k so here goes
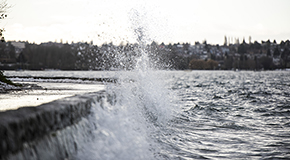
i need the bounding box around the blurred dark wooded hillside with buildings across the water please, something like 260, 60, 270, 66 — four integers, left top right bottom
0, 37, 290, 70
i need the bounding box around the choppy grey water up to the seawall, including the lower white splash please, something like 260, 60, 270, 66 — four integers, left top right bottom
71, 71, 290, 159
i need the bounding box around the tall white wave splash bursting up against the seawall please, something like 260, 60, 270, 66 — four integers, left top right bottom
77, 6, 175, 159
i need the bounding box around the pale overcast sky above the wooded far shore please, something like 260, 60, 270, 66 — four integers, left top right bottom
0, 0, 290, 44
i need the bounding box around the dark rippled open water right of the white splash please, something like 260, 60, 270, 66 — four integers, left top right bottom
158, 71, 290, 159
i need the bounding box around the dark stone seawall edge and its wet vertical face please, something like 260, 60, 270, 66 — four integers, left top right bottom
0, 91, 105, 160
